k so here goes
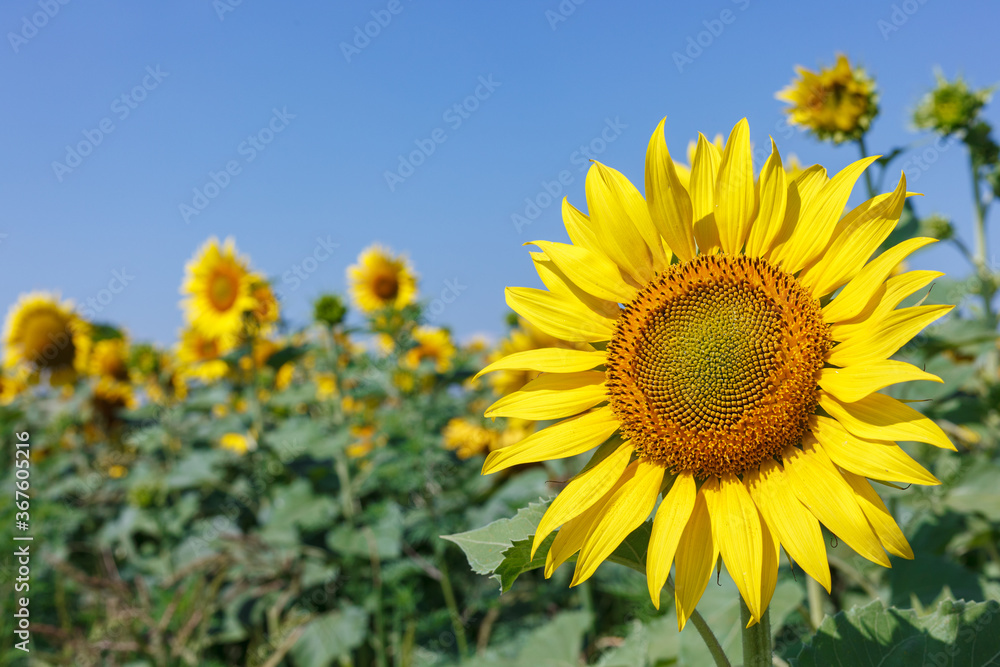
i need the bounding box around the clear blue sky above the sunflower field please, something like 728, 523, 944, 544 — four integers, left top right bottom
0, 0, 1000, 343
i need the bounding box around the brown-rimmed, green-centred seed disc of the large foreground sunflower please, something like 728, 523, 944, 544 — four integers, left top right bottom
607, 255, 831, 477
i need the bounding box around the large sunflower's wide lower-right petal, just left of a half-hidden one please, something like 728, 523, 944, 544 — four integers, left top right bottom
783, 436, 889, 567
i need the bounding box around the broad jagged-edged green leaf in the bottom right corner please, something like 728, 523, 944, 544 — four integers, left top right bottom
793, 600, 1000, 667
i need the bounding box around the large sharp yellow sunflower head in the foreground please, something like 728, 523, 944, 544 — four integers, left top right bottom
483, 119, 954, 628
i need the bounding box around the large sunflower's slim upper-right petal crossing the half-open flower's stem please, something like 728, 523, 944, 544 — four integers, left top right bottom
784, 156, 878, 273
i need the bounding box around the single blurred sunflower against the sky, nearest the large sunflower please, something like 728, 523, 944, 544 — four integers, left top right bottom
347, 244, 417, 313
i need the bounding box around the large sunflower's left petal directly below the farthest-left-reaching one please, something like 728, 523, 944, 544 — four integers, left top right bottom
486, 371, 607, 420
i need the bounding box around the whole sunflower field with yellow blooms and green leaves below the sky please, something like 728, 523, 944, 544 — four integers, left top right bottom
0, 56, 1000, 667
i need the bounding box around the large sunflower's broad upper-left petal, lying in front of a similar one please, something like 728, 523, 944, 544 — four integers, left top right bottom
584, 162, 666, 283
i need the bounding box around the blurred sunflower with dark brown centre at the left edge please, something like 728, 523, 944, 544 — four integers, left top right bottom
3, 292, 91, 385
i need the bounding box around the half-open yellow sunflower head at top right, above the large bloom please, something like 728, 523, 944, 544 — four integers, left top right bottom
775, 54, 878, 144
